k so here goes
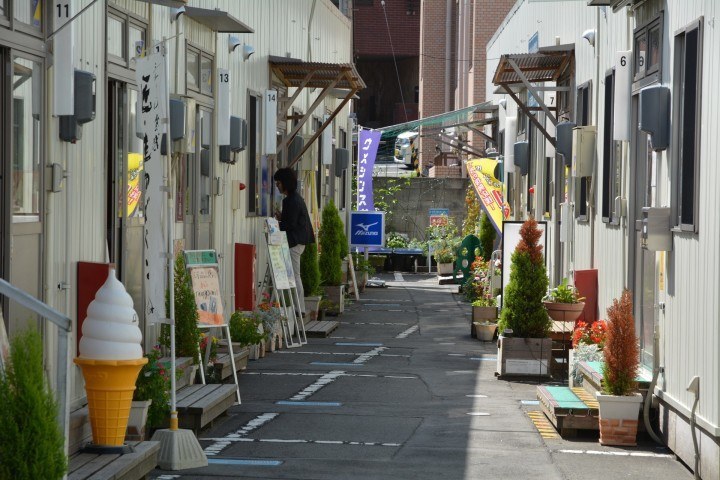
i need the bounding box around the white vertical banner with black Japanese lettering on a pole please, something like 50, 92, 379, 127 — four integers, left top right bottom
135, 49, 169, 322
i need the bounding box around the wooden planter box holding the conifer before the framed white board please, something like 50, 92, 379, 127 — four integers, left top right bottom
496, 336, 552, 377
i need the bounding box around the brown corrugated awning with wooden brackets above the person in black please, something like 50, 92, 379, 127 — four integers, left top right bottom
268, 56, 366, 166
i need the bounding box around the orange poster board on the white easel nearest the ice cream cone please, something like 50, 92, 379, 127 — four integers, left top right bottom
184, 250, 225, 326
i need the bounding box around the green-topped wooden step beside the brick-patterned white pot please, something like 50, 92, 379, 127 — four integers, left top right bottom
537, 385, 600, 438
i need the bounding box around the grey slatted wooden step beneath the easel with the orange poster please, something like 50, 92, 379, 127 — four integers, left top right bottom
177, 383, 236, 434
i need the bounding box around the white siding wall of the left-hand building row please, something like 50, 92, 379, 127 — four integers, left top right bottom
46, 0, 352, 400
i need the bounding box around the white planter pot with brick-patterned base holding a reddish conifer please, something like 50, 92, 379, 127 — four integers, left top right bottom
596, 392, 643, 447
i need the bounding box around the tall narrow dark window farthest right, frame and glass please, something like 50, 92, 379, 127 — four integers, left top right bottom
672, 18, 703, 232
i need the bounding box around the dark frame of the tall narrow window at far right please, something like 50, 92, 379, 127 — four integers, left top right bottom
671, 17, 704, 233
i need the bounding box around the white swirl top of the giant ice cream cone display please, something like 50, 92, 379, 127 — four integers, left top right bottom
79, 269, 143, 360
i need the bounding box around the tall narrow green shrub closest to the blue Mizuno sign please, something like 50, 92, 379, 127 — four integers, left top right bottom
318, 200, 348, 313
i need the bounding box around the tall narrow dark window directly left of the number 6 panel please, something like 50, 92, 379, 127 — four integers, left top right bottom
600, 70, 620, 224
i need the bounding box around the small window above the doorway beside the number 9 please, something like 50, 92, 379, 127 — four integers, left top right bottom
633, 12, 663, 88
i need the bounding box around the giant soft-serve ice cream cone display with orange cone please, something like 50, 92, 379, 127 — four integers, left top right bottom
74, 266, 147, 447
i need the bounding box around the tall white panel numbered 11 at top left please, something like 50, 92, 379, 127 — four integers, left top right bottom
53, 0, 75, 115
